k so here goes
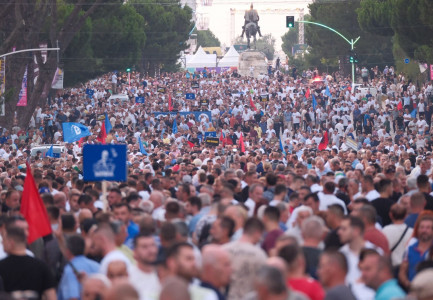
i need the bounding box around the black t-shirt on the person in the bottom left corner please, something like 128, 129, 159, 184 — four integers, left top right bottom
0, 255, 56, 298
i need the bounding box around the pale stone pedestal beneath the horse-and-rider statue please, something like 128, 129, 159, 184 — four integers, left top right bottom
239, 50, 268, 78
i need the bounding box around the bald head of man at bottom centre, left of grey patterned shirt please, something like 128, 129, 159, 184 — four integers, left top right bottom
201, 245, 232, 300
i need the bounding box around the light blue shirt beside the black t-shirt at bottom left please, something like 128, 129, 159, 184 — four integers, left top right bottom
57, 255, 99, 300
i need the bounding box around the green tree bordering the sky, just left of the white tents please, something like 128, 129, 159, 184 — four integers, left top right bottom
129, 0, 193, 74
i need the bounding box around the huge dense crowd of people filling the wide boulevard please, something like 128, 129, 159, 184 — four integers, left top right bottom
0, 62, 433, 300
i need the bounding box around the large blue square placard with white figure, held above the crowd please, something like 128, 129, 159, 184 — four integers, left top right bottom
83, 145, 127, 181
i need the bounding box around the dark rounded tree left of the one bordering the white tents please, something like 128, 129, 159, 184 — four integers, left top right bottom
61, 4, 146, 86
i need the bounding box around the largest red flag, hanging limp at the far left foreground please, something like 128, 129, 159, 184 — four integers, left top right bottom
20, 163, 52, 244
